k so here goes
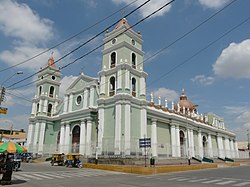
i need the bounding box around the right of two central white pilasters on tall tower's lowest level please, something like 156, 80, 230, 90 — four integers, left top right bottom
124, 104, 131, 155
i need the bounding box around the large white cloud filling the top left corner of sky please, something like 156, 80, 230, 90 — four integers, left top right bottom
0, 0, 53, 43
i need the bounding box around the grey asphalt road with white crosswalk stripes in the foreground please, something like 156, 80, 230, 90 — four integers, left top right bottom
6, 163, 250, 187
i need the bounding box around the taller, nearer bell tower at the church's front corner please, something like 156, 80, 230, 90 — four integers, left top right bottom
98, 18, 147, 155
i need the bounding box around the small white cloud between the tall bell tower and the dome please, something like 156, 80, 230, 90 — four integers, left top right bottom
152, 88, 178, 101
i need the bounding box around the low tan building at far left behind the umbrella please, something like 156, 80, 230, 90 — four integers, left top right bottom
0, 129, 26, 145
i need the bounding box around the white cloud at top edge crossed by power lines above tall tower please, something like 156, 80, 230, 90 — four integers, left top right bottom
112, 0, 171, 17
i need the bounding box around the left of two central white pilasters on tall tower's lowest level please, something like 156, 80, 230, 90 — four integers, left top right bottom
115, 104, 122, 155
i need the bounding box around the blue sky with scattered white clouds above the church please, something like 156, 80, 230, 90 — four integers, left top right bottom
0, 0, 250, 141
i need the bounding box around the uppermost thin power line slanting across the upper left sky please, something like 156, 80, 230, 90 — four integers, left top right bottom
0, 0, 138, 73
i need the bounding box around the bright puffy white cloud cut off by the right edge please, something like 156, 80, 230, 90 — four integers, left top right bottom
213, 39, 250, 78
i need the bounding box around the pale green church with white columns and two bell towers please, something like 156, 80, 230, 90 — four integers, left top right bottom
27, 19, 238, 158
